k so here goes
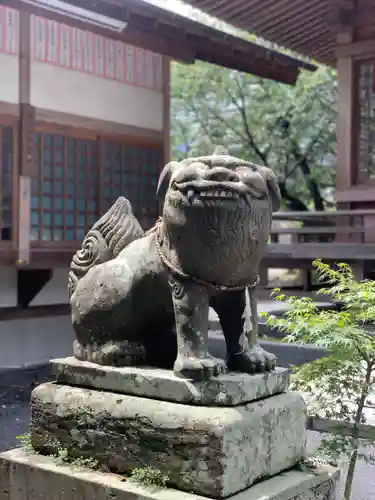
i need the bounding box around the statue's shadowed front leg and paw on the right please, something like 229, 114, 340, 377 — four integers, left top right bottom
212, 291, 276, 373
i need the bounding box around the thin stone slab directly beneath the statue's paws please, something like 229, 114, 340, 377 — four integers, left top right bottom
51, 357, 289, 406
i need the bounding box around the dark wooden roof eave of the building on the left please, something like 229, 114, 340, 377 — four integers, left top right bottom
0, 0, 316, 84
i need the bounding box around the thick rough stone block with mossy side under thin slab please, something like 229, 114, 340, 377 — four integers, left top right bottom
31, 384, 306, 498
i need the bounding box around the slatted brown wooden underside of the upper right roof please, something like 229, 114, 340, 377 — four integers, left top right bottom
185, 0, 375, 66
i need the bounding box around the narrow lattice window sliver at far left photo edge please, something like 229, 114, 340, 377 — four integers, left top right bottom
0, 125, 13, 241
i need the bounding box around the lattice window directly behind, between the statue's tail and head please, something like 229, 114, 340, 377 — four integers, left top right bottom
101, 141, 162, 228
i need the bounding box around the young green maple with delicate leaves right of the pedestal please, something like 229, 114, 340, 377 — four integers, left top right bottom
263, 260, 375, 500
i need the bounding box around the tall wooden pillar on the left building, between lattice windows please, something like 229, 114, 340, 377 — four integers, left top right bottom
17, 10, 35, 265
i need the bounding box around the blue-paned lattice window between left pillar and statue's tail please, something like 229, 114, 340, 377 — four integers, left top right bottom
31, 133, 99, 242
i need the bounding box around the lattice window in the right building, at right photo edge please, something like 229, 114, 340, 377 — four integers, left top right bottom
358, 62, 375, 181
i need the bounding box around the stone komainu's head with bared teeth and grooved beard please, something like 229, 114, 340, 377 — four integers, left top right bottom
157, 148, 281, 286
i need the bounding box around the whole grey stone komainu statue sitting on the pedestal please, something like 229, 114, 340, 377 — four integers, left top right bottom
69, 149, 280, 380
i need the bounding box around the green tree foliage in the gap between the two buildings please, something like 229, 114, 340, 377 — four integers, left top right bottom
171, 62, 336, 209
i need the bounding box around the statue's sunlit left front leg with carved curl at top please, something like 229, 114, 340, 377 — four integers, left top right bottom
170, 278, 226, 380
